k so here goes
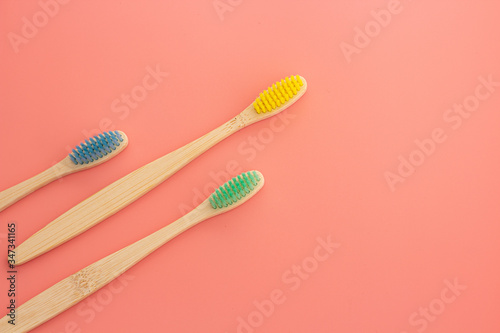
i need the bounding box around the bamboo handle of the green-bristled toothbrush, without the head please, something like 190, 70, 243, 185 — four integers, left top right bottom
0, 208, 207, 333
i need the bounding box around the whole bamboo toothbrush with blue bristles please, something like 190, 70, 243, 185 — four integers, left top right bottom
0, 131, 128, 212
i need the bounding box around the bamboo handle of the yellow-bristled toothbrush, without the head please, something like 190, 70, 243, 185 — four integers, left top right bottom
16, 115, 247, 265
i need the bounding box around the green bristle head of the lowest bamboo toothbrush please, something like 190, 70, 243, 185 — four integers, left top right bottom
209, 171, 260, 209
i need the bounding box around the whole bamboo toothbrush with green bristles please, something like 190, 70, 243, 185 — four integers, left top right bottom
0, 171, 264, 333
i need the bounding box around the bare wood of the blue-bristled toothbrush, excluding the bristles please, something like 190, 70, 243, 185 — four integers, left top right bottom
0, 131, 128, 212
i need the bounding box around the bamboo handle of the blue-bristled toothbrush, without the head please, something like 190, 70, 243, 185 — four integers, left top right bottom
0, 158, 74, 212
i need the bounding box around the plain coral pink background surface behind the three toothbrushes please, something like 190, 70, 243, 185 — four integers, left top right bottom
0, 0, 500, 333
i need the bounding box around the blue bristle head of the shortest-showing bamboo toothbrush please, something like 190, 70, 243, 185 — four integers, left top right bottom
69, 131, 123, 164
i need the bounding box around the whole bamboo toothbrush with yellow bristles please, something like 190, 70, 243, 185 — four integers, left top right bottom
16, 75, 307, 265
